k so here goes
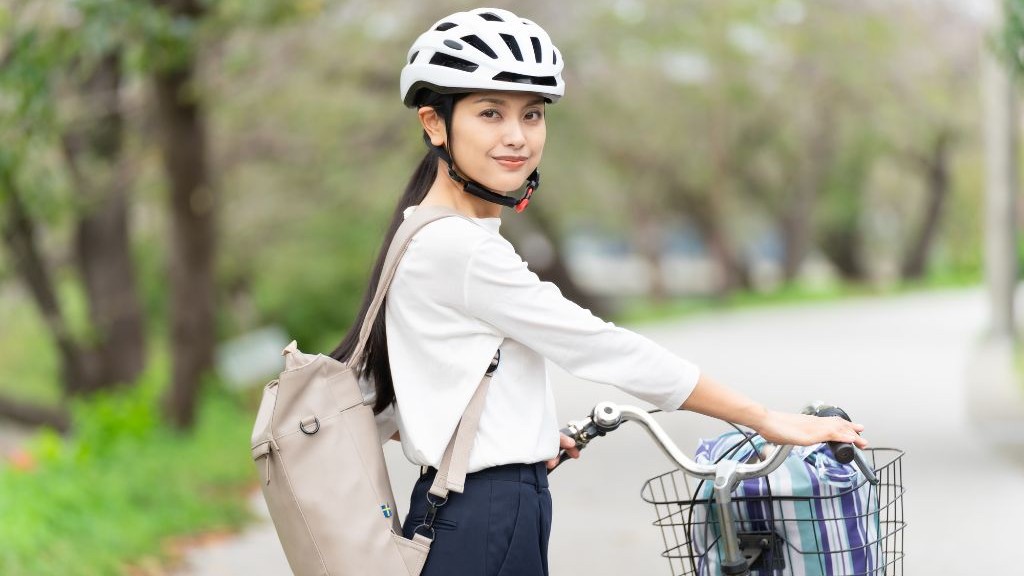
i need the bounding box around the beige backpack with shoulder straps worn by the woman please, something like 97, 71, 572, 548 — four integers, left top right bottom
246, 206, 487, 576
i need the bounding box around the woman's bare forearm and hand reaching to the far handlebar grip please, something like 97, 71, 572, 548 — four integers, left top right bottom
679, 374, 867, 448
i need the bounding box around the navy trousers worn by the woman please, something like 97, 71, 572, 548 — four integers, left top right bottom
402, 462, 551, 576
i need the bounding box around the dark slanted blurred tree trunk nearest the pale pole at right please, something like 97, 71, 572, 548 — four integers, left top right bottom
902, 130, 951, 280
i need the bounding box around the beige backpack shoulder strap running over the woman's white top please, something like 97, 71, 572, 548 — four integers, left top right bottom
348, 206, 501, 498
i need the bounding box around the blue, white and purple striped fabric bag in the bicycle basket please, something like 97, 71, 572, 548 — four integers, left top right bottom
690, 433, 883, 576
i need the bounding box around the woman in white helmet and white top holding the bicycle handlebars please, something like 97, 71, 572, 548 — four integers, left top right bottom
332, 8, 866, 576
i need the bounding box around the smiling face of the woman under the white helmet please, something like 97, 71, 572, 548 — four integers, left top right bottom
451, 92, 547, 193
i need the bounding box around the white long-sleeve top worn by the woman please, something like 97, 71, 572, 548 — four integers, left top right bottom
382, 208, 699, 471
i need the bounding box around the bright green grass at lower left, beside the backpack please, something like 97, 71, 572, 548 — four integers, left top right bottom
0, 372, 253, 576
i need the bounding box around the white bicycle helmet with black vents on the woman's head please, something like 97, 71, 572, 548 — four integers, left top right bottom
400, 8, 565, 108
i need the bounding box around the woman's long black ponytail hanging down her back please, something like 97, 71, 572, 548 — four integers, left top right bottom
331, 89, 462, 414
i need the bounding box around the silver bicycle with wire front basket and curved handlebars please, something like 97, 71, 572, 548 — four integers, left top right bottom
559, 402, 906, 576
